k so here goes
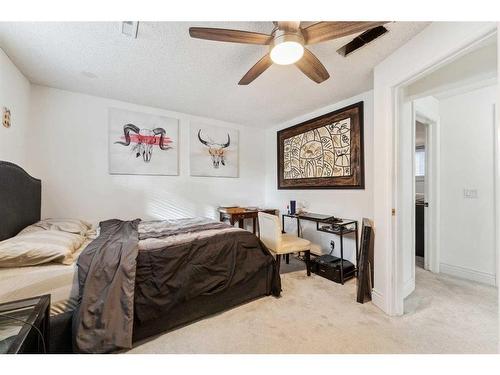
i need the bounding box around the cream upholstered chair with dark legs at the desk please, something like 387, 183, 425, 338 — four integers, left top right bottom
259, 212, 311, 276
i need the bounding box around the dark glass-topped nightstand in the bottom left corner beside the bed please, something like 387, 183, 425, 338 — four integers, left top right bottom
0, 295, 50, 354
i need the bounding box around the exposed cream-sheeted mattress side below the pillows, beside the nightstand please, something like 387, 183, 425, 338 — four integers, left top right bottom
0, 239, 91, 315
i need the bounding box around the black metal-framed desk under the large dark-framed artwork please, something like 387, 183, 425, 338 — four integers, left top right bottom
281, 213, 359, 284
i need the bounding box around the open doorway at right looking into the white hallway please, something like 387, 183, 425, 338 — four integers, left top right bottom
396, 35, 498, 303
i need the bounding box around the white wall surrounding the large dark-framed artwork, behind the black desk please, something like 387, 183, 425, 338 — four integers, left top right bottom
266, 91, 373, 262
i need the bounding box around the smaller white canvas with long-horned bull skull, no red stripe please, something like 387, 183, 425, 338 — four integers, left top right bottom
190, 123, 239, 177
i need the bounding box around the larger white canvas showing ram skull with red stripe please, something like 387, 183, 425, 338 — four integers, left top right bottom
109, 108, 179, 175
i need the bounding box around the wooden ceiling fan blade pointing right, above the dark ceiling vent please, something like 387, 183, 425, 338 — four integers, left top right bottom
302, 21, 387, 44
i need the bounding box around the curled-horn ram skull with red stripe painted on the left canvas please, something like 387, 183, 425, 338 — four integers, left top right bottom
115, 124, 172, 163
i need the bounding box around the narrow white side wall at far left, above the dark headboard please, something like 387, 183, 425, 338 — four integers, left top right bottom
0, 49, 30, 171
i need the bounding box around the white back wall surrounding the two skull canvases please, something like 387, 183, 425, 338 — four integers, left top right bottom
29, 86, 265, 226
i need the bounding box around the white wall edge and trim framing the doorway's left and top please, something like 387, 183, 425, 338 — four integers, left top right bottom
373, 22, 497, 315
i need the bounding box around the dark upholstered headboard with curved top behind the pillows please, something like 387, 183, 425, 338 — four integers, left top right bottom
0, 161, 42, 241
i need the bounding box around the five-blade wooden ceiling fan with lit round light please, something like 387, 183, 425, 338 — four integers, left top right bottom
189, 21, 387, 85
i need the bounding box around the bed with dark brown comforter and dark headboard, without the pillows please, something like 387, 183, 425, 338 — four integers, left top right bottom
0, 161, 281, 353
